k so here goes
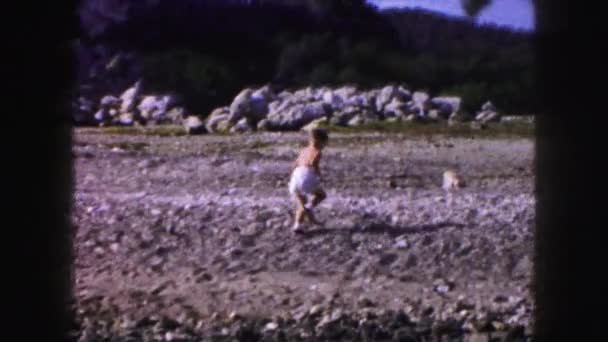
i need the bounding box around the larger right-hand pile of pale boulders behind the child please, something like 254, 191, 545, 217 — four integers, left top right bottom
205, 85, 500, 133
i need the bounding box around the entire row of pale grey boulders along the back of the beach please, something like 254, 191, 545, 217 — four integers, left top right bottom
74, 81, 501, 134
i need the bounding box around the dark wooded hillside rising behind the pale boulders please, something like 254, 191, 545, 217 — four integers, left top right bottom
92, 0, 538, 116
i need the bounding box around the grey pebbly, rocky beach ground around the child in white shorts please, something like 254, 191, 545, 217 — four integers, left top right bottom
73, 129, 535, 341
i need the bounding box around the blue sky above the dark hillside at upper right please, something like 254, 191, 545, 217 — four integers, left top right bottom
368, 0, 534, 31
